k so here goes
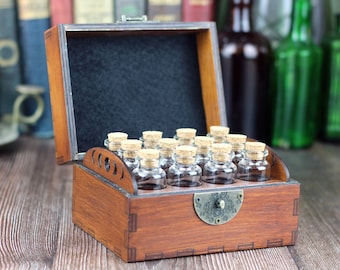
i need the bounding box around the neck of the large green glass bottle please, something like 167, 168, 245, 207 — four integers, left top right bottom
290, 0, 312, 42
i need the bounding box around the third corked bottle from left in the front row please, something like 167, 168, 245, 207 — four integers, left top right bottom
202, 143, 237, 185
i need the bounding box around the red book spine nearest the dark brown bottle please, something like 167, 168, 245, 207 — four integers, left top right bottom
182, 0, 215, 22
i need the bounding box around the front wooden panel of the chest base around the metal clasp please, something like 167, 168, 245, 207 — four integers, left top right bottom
129, 184, 300, 261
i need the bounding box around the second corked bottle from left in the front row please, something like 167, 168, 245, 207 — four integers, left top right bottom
168, 145, 202, 187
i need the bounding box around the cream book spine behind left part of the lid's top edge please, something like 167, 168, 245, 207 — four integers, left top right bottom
73, 0, 114, 24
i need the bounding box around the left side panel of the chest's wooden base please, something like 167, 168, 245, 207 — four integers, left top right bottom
72, 165, 129, 260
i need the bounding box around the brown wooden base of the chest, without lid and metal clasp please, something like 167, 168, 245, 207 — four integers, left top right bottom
73, 148, 300, 262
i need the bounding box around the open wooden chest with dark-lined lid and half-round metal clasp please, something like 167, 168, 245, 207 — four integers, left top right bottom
45, 22, 300, 262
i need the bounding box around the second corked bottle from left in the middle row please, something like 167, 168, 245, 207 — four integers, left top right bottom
159, 138, 178, 174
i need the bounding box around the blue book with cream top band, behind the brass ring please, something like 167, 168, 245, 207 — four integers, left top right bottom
17, 0, 53, 138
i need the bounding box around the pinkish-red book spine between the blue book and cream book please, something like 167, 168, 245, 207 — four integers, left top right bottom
50, 0, 73, 26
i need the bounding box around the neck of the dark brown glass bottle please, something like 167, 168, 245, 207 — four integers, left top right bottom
229, 0, 253, 32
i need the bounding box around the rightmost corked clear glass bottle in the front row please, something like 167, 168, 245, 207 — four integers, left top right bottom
237, 142, 270, 182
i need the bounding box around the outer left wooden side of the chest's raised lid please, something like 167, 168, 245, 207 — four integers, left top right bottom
45, 26, 72, 164
